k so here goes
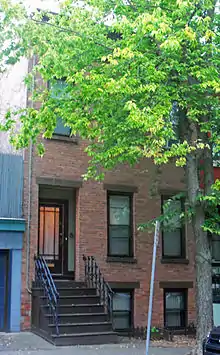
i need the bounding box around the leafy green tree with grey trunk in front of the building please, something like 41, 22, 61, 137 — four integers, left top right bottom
0, 0, 220, 354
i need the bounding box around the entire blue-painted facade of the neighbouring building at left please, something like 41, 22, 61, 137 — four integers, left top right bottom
0, 154, 25, 332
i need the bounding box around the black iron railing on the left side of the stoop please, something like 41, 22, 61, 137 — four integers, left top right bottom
35, 256, 59, 335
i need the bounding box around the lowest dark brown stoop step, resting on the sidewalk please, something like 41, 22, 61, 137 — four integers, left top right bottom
52, 331, 118, 346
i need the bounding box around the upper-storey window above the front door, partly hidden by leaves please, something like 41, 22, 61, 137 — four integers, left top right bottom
49, 79, 71, 137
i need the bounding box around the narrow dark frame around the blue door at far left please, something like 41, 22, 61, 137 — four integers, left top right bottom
0, 249, 10, 331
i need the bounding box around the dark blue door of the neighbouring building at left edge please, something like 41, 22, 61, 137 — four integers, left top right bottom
0, 251, 7, 331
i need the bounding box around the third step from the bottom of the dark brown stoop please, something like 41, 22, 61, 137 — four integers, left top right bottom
45, 313, 108, 324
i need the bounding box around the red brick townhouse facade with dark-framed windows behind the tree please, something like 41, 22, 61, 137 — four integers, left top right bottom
22, 78, 195, 340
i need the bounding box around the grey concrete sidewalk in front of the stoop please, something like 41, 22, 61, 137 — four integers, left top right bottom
0, 333, 189, 355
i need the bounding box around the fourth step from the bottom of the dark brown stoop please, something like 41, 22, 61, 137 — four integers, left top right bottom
41, 303, 104, 314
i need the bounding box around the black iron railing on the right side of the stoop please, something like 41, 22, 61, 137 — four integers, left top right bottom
83, 255, 114, 322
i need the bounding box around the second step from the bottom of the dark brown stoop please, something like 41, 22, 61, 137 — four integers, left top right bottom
48, 322, 112, 334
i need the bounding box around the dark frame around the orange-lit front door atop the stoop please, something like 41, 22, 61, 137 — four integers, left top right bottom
38, 198, 69, 275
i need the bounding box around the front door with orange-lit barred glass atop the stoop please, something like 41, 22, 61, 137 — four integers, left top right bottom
38, 200, 68, 275
